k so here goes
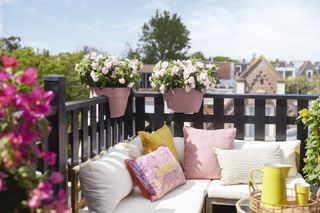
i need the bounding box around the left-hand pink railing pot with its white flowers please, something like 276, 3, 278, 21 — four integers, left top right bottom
75, 52, 142, 118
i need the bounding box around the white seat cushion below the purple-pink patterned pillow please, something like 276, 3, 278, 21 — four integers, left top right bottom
80, 180, 210, 213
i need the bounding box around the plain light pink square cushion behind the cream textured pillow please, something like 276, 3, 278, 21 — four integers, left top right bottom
183, 127, 236, 179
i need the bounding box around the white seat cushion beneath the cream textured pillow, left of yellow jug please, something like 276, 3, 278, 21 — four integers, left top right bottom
208, 174, 305, 199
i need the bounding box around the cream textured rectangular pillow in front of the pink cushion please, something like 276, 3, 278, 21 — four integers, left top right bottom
215, 146, 281, 185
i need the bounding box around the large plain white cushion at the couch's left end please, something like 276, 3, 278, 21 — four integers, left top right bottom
80, 144, 133, 213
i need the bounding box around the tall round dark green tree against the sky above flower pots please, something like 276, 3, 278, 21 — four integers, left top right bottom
139, 10, 190, 64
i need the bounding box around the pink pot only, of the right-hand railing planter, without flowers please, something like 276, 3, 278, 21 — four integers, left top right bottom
163, 88, 203, 113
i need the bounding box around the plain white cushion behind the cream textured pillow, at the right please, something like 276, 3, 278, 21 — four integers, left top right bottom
235, 140, 301, 177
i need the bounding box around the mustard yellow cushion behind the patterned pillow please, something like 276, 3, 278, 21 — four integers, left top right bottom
138, 125, 179, 160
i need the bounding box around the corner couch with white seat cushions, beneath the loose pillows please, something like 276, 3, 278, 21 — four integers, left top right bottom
72, 137, 304, 213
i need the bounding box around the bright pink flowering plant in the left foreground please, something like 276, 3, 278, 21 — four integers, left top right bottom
0, 56, 68, 213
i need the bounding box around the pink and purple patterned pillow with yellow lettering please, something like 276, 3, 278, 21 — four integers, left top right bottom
125, 145, 186, 201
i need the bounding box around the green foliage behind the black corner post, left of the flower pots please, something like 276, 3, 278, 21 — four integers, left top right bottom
5, 47, 89, 101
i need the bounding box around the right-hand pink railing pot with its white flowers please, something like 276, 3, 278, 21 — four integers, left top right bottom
150, 59, 218, 113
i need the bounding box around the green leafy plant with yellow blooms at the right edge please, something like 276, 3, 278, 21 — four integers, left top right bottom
297, 98, 320, 193
